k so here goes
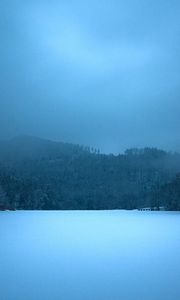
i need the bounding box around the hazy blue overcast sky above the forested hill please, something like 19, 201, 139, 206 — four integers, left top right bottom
0, 0, 180, 153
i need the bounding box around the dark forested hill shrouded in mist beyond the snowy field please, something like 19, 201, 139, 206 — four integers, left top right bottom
0, 137, 180, 210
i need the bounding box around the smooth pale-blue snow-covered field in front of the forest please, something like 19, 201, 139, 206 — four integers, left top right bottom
0, 211, 180, 300
